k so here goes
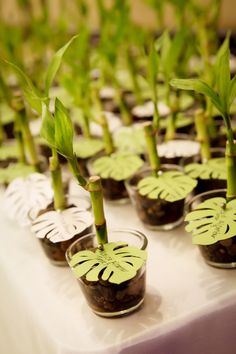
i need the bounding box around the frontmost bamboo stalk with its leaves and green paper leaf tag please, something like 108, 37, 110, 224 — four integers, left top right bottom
41, 99, 146, 310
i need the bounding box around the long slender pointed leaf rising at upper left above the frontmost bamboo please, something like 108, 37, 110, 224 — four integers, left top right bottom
45, 35, 78, 97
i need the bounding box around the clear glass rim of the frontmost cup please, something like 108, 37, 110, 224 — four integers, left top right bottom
65, 228, 148, 263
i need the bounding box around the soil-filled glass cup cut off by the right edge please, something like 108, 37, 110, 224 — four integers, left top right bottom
186, 189, 236, 268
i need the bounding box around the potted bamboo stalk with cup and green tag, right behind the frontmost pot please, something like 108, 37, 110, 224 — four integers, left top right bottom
127, 122, 197, 230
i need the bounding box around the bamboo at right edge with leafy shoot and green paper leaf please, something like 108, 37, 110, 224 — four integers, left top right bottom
171, 37, 236, 265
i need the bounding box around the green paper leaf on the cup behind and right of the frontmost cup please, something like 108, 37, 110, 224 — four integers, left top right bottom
138, 171, 197, 202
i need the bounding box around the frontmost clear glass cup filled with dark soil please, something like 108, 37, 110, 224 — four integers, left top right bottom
66, 229, 148, 317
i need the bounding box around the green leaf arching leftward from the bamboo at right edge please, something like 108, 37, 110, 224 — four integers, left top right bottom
170, 79, 225, 115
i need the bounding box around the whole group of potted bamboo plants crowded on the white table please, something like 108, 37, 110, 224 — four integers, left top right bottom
0, 0, 236, 317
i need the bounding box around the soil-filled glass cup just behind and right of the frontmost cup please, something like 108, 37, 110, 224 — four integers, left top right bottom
125, 164, 185, 230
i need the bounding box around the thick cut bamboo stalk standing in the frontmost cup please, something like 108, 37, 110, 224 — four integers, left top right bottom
88, 176, 108, 247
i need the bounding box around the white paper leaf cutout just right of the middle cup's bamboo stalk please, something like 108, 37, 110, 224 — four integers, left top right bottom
157, 140, 200, 158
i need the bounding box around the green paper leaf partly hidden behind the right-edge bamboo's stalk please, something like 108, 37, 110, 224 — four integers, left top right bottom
184, 157, 227, 180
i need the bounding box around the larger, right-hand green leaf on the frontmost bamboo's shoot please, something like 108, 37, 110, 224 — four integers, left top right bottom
55, 99, 74, 159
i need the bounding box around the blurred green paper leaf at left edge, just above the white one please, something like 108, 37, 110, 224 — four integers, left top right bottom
0, 163, 35, 183
